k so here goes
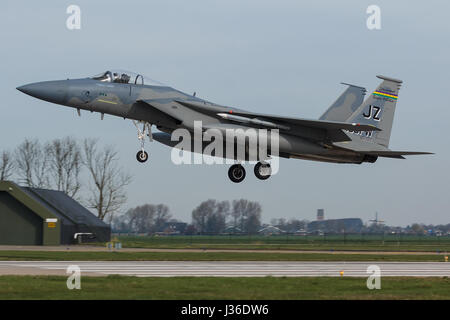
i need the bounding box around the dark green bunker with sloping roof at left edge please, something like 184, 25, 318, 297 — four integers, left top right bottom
0, 181, 111, 245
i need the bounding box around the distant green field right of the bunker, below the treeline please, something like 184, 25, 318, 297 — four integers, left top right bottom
110, 235, 450, 252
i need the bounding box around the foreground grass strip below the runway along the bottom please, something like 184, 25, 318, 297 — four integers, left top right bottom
0, 276, 450, 300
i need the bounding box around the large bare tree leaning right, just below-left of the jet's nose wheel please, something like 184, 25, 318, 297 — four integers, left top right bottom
83, 139, 131, 220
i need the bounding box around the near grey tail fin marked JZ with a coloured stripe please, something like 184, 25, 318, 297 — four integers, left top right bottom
346, 76, 402, 148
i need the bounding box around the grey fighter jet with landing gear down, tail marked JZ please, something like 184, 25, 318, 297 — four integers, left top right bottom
17, 70, 430, 183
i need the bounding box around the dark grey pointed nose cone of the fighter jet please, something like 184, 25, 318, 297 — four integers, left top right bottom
16, 80, 67, 103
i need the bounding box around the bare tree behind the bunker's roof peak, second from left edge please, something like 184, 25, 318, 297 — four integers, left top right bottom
16, 139, 50, 188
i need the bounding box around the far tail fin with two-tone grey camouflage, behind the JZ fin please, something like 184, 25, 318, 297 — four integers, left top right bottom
319, 83, 366, 122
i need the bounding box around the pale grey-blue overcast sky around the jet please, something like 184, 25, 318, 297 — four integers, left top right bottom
0, 0, 450, 226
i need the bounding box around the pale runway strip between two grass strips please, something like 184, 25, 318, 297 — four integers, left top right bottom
0, 261, 450, 277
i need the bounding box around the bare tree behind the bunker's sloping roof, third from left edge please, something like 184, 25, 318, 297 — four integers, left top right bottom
45, 137, 82, 198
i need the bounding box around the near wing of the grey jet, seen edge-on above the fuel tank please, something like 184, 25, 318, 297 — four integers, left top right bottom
176, 101, 380, 141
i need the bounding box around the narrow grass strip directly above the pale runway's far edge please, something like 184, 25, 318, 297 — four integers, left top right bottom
0, 251, 444, 262
